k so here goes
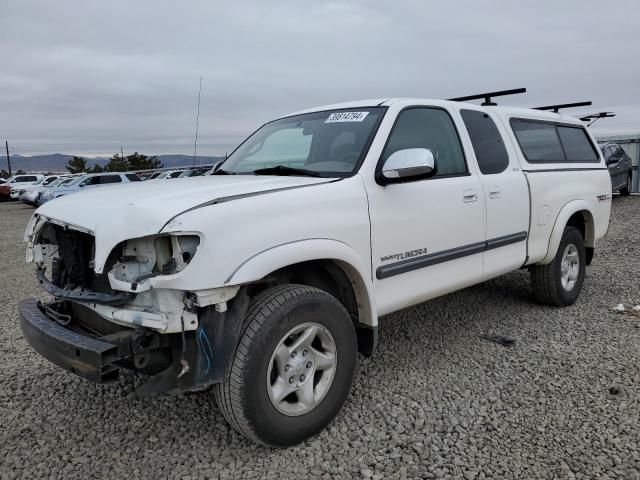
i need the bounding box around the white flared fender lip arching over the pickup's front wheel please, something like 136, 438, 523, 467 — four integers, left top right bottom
225, 238, 378, 327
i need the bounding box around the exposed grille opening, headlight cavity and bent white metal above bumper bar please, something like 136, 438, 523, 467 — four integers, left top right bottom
27, 218, 238, 333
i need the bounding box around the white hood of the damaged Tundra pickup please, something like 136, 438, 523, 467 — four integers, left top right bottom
32, 175, 331, 272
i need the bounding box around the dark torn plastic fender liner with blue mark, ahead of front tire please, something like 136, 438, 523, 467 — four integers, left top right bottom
136, 289, 249, 396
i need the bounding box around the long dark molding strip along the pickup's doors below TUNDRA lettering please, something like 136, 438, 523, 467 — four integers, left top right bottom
376, 232, 528, 280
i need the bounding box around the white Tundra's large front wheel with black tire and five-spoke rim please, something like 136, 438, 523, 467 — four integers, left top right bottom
214, 285, 357, 447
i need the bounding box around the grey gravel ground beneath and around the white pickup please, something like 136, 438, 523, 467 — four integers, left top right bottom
0, 196, 640, 479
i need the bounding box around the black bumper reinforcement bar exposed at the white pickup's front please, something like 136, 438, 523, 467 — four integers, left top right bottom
19, 298, 120, 383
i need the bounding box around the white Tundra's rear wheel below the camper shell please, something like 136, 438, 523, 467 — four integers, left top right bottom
531, 226, 586, 307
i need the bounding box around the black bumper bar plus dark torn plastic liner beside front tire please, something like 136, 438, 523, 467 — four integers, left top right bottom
19, 291, 249, 396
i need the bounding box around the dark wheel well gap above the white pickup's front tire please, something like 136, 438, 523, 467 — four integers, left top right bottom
248, 260, 377, 355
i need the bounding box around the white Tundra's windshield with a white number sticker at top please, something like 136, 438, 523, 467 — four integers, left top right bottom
220, 107, 386, 177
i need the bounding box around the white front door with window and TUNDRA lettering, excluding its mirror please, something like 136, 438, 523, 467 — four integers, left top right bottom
368, 107, 485, 315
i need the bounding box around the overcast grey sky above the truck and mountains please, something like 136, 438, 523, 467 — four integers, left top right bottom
0, 0, 640, 155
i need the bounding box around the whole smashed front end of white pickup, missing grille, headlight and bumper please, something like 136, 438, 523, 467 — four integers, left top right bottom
20, 215, 248, 395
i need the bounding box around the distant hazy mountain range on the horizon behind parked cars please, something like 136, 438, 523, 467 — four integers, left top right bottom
0, 153, 224, 172
